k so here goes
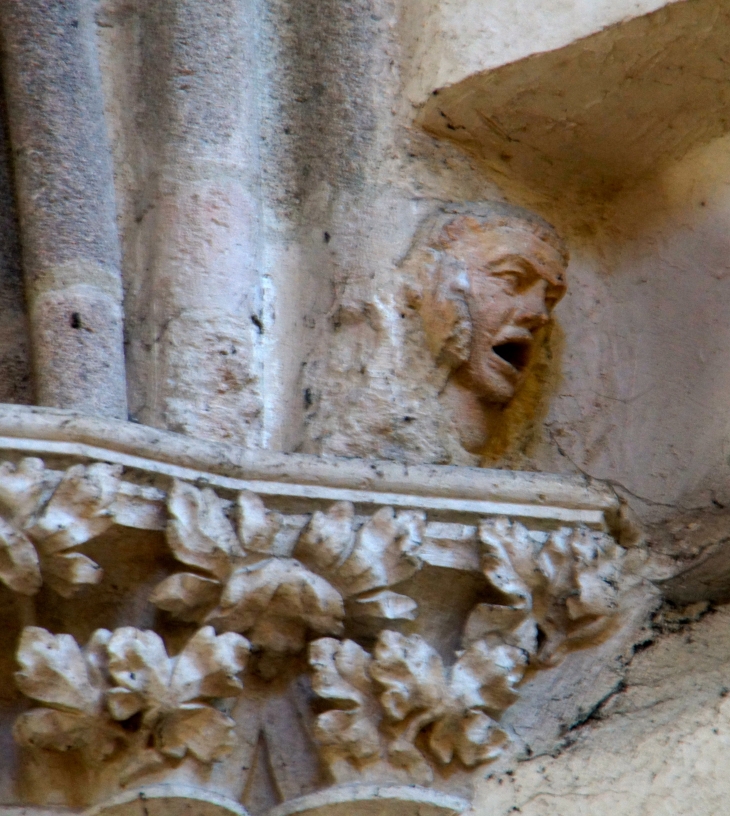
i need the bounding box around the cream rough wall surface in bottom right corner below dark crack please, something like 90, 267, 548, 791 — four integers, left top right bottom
475, 608, 730, 816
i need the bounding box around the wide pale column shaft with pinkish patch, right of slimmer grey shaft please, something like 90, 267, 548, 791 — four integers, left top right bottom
128, 0, 262, 446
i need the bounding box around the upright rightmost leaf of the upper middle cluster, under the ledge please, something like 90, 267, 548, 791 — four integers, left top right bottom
328, 507, 425, 597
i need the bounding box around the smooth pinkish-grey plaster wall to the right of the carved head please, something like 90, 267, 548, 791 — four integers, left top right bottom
533, 130, 730, 516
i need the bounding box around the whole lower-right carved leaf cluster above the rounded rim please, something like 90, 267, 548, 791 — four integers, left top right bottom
309, 630, 526, 784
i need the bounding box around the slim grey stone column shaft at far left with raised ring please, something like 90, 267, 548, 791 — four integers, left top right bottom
0, 0, 127, 419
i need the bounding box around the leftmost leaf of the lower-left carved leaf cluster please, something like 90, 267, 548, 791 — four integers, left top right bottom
15, 626, 102, 715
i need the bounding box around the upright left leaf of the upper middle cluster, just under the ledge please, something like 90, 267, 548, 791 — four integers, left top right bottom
167, 480, 244, 580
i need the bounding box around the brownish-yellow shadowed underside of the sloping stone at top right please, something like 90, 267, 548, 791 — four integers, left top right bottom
418, 0, 730, 197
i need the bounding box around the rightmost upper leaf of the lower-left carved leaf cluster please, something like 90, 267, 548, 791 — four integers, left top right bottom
170, 626, 250, 706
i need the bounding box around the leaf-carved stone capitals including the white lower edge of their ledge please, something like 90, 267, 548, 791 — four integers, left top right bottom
0, 414, 639, 814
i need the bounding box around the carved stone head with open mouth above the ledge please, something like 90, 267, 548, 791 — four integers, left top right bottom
418, 203, 568, 453
